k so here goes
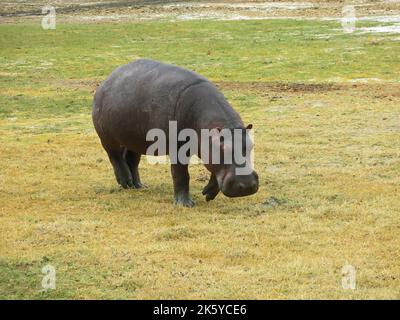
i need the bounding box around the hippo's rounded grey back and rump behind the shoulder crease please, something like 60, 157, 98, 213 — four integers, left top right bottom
93, 59, 208, 149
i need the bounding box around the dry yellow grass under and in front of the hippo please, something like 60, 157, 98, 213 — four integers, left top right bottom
0, 82, 400, 299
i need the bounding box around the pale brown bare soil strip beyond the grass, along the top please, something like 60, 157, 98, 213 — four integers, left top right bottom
0, 0, 400, 23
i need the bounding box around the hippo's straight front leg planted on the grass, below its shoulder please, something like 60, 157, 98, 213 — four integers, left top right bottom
171, 164, 194, 207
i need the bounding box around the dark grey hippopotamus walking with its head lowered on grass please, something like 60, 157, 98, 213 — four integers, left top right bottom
92, 59, 259, 207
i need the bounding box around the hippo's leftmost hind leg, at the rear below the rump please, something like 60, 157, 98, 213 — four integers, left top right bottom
101, 140, 133, 189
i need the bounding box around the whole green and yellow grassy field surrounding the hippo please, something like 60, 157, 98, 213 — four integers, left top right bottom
0, 16, 400, 299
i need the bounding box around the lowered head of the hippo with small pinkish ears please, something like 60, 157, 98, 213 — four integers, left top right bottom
205, 124, 258, 197
